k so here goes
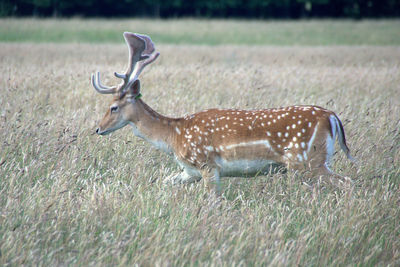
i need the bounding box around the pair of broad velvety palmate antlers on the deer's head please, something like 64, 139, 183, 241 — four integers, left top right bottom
92, 32, 160, 94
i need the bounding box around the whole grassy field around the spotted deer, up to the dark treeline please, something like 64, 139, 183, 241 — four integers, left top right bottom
0, 19, 400, 266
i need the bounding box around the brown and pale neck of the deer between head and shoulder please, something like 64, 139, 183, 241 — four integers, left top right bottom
129, 99, 177, 154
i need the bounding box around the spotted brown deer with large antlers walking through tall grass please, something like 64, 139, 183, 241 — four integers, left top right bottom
91, 32, 353, 192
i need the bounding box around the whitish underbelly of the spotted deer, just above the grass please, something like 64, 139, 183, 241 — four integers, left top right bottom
215, 157, 280, 176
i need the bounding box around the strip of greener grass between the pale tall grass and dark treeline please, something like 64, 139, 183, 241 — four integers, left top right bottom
0, 19, 400, 46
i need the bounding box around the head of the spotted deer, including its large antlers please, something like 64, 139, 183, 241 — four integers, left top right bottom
91, 32, 160, 135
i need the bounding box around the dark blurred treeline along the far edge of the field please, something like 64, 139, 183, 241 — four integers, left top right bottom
0, 0, 400, 19
